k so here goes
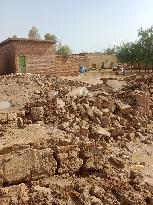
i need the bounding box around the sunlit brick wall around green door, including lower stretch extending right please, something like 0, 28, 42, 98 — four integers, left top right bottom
15, 42, 88, 76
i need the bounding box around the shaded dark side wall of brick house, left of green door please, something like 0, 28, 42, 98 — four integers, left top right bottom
0, 43, 15, 75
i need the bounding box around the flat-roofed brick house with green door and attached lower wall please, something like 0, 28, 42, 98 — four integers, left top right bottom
0, 38, 88, 76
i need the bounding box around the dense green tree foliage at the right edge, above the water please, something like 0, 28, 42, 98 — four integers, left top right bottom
115, 26, 153, 70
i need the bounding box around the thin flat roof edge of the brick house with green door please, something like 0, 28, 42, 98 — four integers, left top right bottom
0, 38, 56, 46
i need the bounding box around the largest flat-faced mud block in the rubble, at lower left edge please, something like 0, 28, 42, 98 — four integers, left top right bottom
0, 148, 56, 184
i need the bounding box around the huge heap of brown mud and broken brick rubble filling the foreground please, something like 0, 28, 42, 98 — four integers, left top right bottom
0, 74, 153, 205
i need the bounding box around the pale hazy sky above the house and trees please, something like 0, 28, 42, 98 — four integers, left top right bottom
0, 0, 153, 52
